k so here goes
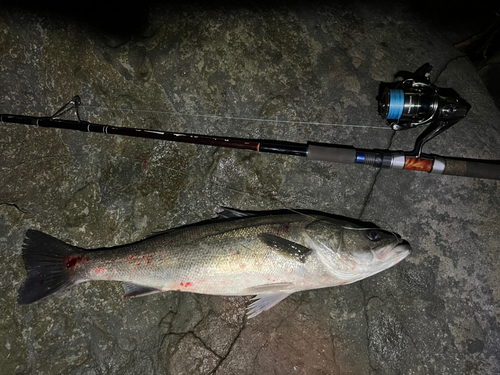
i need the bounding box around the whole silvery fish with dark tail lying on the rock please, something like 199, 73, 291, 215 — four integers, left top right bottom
18, 208, 411, 318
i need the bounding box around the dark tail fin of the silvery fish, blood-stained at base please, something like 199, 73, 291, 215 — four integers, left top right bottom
18, 229, 85, 305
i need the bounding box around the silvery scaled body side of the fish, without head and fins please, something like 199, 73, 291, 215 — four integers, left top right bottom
80, 215, 319, 295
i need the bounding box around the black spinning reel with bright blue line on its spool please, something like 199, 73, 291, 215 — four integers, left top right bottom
378, 63, 471, 157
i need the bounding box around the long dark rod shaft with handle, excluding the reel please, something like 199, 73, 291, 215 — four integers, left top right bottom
0, 115, 500, 180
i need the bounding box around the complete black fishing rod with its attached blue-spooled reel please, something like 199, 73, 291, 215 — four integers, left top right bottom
0, 64, 500, 180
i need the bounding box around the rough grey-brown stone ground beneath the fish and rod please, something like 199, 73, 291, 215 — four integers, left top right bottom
0, 2, 500, 375
